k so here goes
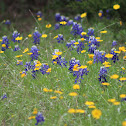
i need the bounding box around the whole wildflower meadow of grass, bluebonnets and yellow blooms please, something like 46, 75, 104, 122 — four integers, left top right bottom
0, 0, 126, 126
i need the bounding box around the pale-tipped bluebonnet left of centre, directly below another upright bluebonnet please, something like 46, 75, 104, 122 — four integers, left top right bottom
30, 45, 40, 61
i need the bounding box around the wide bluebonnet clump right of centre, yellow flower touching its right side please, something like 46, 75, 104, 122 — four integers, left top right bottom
93, 50, 107, 63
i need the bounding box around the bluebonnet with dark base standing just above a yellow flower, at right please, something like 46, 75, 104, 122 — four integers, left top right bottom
98, 67, 107, 83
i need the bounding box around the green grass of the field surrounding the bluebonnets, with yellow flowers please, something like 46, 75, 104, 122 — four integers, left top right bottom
0, 13, 126, 126
